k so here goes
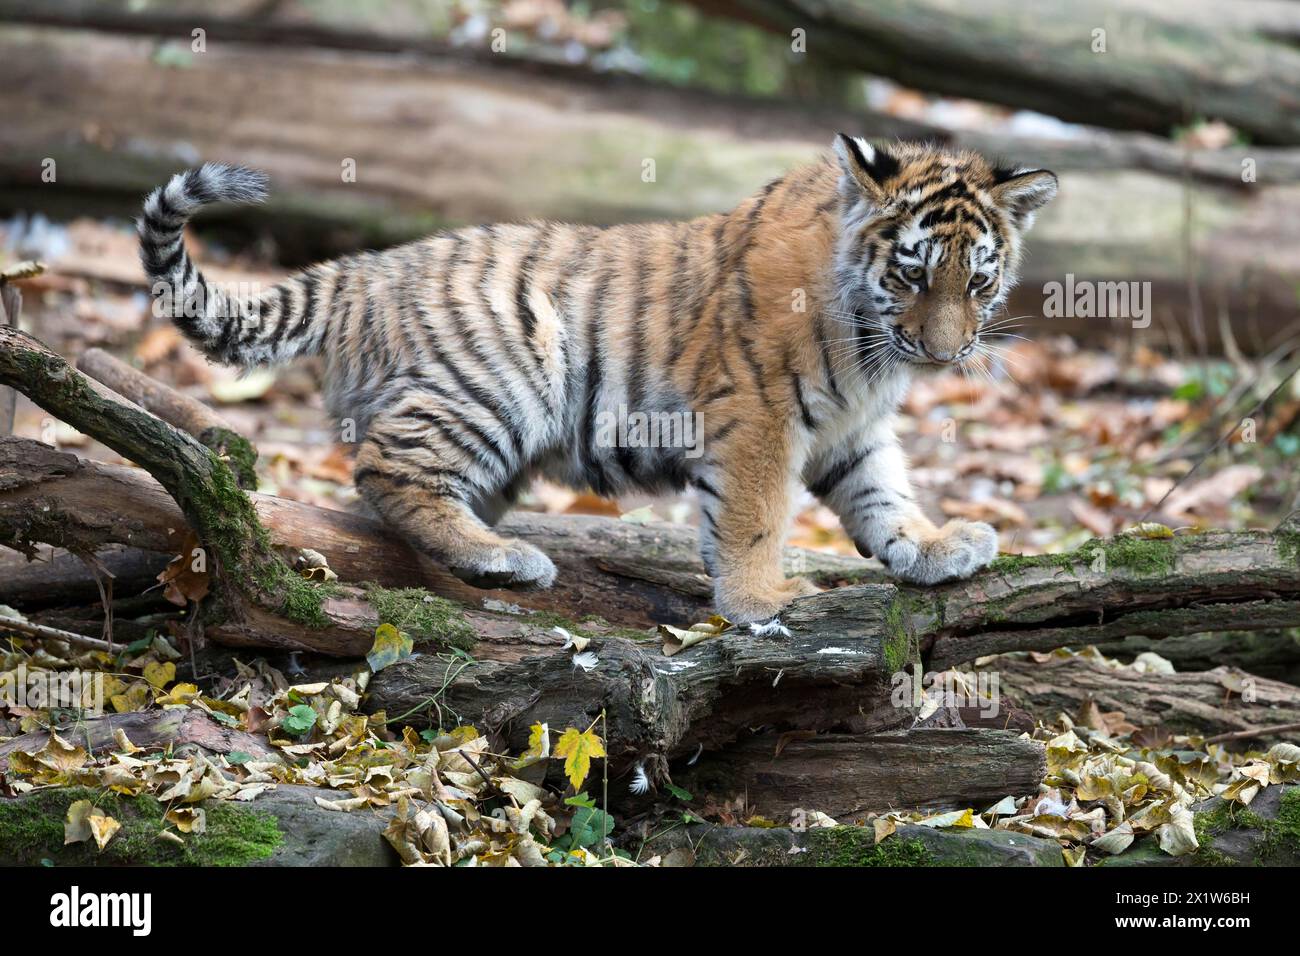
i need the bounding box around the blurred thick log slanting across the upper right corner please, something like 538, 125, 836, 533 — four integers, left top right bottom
692, 0, 1300, 143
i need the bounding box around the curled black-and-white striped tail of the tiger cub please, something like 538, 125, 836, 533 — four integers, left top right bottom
138, 163, 324, 367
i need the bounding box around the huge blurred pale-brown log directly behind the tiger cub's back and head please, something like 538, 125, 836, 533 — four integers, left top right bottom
0, 13, 1300, 350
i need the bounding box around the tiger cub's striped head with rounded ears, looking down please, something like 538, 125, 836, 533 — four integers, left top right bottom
835, 134, 1057, 365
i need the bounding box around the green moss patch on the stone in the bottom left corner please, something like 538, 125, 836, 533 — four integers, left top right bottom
0, 787, 283, 866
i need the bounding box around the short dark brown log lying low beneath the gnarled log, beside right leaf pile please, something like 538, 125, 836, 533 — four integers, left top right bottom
672, 728, 1047, 822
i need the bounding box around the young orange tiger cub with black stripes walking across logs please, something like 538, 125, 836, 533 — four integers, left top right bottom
139, 135, 1057, 622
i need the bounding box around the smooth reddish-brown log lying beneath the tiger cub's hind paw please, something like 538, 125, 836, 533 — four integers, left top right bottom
0, 438, 871, 627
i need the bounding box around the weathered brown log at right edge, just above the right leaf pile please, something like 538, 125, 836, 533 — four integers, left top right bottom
988, 656, 1300, 747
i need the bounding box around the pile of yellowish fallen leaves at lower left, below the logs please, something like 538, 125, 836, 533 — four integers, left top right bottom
0, 628, 629, 866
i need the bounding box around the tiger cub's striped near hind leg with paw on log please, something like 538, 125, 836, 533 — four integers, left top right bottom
356, 412, 555, 589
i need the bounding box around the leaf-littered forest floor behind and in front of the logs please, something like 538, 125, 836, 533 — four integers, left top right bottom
0, 214, 1300, 865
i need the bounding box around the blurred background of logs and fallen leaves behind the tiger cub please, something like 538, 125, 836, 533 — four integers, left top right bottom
0, 0, 1300, 553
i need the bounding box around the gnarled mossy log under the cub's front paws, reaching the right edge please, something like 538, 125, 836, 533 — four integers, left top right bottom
369, 519, 1300, 763
